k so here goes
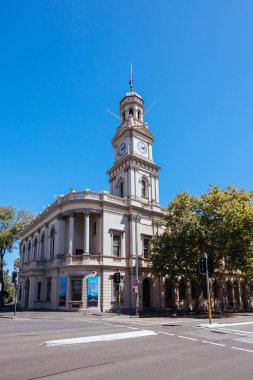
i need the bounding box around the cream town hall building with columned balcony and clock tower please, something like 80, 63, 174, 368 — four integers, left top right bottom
19, 81, 164, 312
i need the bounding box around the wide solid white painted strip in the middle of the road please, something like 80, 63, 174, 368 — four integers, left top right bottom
42, 330, 157, 346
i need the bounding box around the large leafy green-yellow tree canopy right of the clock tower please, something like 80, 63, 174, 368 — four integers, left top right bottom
150, 186, 253, 281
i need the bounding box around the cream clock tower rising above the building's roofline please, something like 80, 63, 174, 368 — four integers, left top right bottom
107, 79, 160, 206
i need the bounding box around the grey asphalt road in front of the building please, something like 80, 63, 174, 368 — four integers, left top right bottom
0, 312, 253, 380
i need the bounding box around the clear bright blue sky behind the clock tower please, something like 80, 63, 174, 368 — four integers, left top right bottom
0, 0, 253, 268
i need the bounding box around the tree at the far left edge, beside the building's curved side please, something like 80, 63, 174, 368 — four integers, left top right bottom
0, 206, 32, 306
